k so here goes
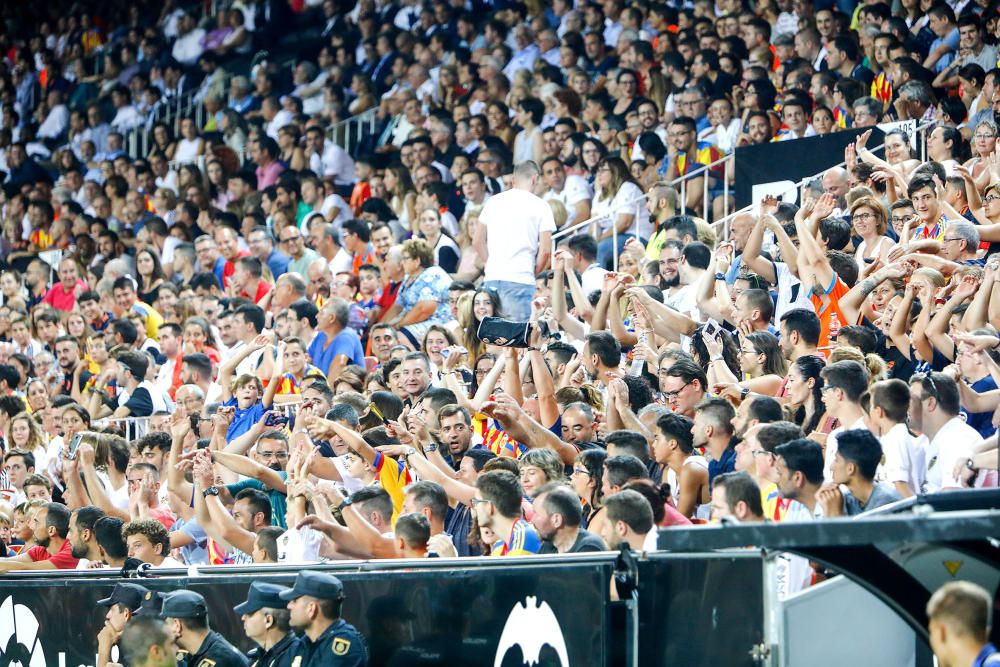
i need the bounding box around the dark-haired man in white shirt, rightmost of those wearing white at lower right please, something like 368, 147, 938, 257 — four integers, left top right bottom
908, 373, 982, 493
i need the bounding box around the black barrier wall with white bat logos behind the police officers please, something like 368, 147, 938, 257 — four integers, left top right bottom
0, 554, 614, 667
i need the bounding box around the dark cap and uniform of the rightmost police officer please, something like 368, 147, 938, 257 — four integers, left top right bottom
281, 571, 368, 667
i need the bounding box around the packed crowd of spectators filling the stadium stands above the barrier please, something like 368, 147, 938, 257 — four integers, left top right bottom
0, 0, 1000, 656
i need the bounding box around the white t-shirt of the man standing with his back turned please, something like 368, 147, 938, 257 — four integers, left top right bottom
479, 188, 556, 285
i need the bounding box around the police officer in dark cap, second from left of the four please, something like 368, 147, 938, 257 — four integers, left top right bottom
160, 591, 249, 667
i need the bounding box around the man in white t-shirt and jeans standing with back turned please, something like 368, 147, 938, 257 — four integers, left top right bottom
474, 160, 556, 321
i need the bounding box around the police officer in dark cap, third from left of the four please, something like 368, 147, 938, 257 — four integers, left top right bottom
233, 581, 298, 667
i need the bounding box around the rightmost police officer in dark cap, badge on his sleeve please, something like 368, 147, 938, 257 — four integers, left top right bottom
281, 571, 368, 667
